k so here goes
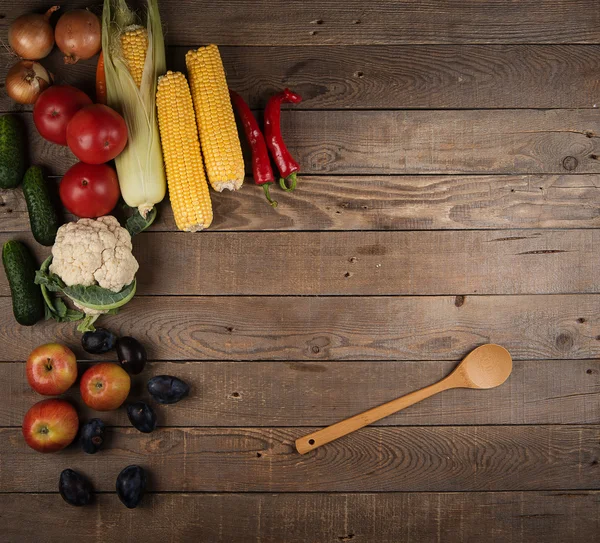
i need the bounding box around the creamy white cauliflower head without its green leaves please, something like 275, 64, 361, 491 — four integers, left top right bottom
50, 215, 139, 292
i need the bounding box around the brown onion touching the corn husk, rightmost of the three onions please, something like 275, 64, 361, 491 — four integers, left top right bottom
54, 9, 102, 64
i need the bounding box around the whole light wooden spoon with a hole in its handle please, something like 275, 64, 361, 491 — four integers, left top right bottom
296, 344, 512, 454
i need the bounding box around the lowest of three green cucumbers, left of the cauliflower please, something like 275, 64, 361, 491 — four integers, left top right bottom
2, 240, 45, 326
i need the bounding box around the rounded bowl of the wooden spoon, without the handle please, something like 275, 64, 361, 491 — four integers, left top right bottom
448, 343, 512, 389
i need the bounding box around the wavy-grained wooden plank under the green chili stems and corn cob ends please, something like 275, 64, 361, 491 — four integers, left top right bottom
0, 175, 600, 232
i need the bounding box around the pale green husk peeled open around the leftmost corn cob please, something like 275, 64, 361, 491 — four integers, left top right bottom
102, 0, 167, 217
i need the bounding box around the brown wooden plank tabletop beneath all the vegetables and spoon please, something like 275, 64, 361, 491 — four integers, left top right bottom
0, 0, 600, 543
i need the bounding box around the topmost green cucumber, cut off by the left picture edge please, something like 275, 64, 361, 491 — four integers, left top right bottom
0, 115, 25, 189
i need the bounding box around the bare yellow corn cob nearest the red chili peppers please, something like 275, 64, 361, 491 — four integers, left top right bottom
185, 45, 244, 192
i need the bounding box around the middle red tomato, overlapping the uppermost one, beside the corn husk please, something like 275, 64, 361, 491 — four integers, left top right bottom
67, 104, 127, 164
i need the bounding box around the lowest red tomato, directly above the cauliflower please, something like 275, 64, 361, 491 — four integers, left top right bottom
59, 162, 121, 219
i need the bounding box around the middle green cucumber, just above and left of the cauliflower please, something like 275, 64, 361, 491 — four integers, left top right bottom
23, 166, 58, 247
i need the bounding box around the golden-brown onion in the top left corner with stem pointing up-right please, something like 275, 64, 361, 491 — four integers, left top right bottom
8, 6, 60, 60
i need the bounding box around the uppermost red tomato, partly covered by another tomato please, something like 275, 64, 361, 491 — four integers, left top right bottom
33, 85, 92, 145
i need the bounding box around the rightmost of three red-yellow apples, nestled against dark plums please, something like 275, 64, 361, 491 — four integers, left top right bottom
79, 362, 131, 411
